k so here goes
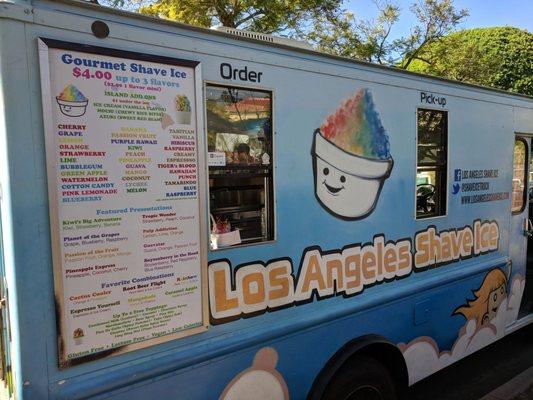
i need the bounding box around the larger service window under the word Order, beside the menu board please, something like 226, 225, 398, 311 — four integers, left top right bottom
206, 85, 274, 249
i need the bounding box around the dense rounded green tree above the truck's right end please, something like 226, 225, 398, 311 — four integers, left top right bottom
408, 27, 533, 95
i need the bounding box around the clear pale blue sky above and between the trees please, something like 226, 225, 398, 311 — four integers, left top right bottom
345, 0, 533, 39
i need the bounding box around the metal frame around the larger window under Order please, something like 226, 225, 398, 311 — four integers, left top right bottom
202, 80, 278, 251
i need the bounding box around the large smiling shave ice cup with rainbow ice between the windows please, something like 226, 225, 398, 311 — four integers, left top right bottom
312, 89, 393, 220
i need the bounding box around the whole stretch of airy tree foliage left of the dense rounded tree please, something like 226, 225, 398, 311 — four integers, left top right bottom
100, 0, 468, 68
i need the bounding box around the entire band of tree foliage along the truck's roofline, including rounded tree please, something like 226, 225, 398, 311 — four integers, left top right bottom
99, 0, 533, 95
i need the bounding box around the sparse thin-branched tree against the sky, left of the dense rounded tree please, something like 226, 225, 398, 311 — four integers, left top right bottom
307, 0, 468, 69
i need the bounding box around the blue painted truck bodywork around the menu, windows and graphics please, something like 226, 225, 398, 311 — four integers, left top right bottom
0, 1, 533, 400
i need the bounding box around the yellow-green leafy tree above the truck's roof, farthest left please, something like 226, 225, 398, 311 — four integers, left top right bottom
101, 0, 343, 36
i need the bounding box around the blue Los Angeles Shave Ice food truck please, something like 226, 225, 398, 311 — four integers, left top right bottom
0, 0, 533, 400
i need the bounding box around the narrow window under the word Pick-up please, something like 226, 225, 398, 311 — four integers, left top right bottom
416, 109, 448, 218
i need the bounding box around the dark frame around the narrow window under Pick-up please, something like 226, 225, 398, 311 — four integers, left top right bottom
414, 106, 450, 221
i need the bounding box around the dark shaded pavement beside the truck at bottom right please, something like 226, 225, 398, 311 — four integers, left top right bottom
405, 324, 533, 400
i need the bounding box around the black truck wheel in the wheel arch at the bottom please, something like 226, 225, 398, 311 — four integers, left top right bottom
322, 356, 396, 400
